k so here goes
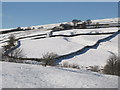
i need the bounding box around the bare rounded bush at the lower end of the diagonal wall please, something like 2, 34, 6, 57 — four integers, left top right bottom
42, 52, 58, 67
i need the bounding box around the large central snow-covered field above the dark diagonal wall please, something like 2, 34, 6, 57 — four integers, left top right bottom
21, 35, 111, 58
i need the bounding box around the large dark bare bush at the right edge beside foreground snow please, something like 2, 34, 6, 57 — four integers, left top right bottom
103, 55, 120, 76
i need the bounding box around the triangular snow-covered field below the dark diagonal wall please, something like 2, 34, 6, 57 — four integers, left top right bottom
62, 36, 118, 67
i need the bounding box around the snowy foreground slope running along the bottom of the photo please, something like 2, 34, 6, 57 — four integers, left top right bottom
0, 62, 118, 88
